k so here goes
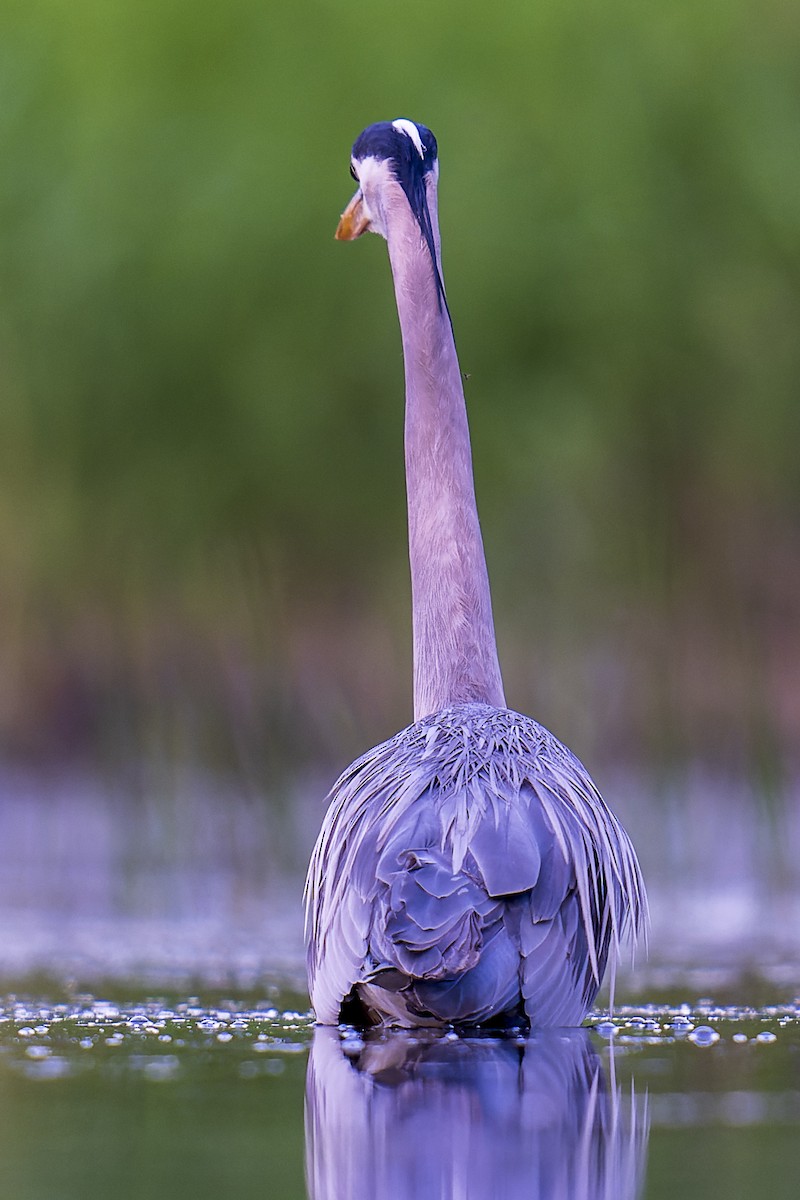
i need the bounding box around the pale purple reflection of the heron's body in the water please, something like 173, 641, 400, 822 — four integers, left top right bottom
306, 1028, 648, 1200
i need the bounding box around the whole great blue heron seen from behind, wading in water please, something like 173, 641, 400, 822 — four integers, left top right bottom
306, 119, 646, 1026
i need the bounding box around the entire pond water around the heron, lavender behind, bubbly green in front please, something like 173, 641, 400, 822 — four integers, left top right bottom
0, 773, 800, 1200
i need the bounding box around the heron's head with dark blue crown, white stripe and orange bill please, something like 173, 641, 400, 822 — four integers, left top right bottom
336, 118, 439, 250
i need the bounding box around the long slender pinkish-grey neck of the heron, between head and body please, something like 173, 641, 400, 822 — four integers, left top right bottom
389, 188, 505, 720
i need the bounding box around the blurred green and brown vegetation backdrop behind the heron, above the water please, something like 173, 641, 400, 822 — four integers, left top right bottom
0, 0, 800, 793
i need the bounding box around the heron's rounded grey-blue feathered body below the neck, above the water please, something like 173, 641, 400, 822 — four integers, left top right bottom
306, 704, 646, 1026
